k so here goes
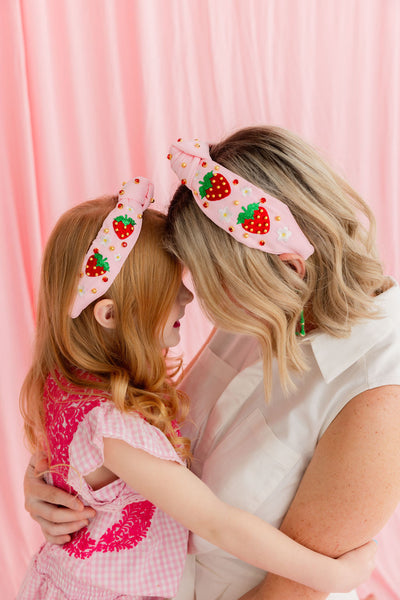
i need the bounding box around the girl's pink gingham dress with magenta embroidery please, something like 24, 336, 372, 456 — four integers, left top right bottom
18, 377, 188, 600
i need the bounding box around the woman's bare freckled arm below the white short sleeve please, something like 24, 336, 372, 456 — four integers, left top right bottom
238, 386, 400, 600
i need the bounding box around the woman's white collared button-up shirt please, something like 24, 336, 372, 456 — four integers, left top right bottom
177, 284, 400, 600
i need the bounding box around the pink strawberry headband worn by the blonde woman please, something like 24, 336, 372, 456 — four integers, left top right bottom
168, 138, 314, 259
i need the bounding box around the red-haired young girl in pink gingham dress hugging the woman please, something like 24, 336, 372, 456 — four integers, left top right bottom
18, 177, 374, 600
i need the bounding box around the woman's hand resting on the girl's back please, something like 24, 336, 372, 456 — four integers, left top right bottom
24, 455, 96, 544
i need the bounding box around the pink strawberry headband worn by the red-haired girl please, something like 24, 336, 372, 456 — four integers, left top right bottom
70, 177, 154, 319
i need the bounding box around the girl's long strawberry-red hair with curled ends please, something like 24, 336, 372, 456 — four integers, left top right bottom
20, 196, 190, 458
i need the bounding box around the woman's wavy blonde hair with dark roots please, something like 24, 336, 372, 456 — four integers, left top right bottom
166, 127, 391, 398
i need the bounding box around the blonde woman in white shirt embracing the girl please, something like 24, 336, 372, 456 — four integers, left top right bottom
26, 128, 400, 600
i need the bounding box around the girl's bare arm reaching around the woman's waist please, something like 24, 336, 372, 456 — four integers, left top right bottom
104, 438, 375, 592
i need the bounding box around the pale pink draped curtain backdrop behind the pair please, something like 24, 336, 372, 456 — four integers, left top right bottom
0, 0, 400, 600
